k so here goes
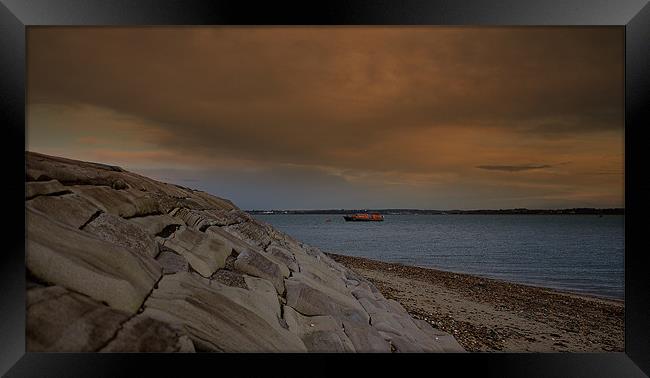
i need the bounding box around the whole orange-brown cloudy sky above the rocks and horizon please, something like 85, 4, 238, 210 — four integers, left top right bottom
26, 27, 624, 210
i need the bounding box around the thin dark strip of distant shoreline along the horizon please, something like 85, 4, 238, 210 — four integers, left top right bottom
246, 208, 625, 215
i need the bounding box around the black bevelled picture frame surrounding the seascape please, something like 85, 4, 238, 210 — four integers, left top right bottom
0, 0, 650, 377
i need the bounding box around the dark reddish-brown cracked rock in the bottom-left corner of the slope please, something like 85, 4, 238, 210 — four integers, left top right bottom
27, 285, 194, 352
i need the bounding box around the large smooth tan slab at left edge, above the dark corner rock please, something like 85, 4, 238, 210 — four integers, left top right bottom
26, 207, 161, 312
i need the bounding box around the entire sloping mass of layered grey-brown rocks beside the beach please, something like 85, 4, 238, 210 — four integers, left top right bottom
25, 153, 463, 352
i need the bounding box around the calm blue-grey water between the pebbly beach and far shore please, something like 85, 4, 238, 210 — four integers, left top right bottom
255, 215, 624, 299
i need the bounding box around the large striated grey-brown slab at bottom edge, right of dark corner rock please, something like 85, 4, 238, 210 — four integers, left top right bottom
144, 272, 305, 352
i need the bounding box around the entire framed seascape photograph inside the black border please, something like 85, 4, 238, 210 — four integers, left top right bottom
25, 26, 625, 353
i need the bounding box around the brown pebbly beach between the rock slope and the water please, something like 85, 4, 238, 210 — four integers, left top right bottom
328, 254, 624, 352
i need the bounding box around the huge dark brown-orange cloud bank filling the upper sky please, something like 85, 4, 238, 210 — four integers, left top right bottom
28, 27, 623, 170
